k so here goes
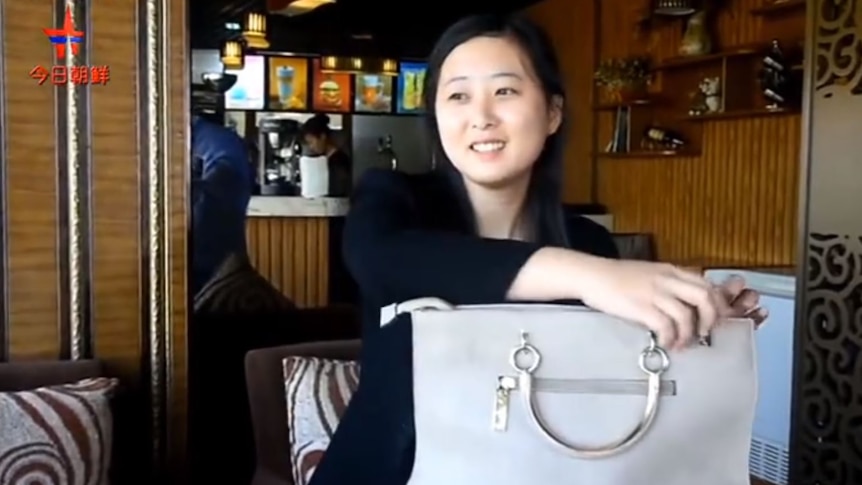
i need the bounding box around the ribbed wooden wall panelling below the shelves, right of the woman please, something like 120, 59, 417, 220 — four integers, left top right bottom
599, 116, 800, 266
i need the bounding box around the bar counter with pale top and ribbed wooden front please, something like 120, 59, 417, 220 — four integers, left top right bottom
246, 196, 349, 308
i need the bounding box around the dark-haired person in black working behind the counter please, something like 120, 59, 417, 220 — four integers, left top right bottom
300, 114, 353, 197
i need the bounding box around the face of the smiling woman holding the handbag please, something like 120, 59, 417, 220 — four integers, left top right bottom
434, 37, 562, 187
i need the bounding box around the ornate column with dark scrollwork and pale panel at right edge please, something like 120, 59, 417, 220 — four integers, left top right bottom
790, 0, 862, 485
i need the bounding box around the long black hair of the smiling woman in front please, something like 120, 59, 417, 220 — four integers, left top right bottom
424, 15, 568, 246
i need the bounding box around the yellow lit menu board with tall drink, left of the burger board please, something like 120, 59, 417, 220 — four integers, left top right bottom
266, 57, 309, 111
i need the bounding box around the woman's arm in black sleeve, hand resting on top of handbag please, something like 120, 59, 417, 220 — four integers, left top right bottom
344, 171, 729, 347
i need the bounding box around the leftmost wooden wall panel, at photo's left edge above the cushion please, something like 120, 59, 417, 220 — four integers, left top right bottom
0, 0, 60, 359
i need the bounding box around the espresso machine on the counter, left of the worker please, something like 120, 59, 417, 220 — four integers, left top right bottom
258, 118, 302, 195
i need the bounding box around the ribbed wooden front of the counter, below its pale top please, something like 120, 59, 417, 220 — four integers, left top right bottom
246, 217, 329, 308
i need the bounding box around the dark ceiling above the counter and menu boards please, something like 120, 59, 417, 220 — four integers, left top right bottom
189, 0, 538, 58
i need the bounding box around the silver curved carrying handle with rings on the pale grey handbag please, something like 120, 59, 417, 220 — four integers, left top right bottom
509, 332, 670, 459
